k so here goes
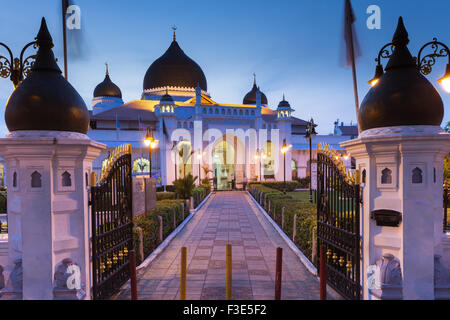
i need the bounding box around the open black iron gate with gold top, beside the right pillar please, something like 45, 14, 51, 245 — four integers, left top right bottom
317, 144, 361, 300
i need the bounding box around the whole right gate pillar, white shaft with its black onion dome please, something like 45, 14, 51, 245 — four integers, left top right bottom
341, 17, 450, 300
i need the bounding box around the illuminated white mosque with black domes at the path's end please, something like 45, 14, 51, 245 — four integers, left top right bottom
88, 30, 356, 190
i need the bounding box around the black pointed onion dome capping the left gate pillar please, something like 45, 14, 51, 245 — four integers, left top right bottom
5, 18, 89, 134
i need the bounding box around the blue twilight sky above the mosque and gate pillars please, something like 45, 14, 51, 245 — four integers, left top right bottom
0, 0, 450, 136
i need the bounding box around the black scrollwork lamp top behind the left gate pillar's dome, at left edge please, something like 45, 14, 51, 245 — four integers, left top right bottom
0, 41, 37, 89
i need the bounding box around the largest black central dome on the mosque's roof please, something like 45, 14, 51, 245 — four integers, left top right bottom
144, 39, 208, 91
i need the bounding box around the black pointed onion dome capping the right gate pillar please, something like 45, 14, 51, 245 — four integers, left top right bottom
358, 17, 444, 131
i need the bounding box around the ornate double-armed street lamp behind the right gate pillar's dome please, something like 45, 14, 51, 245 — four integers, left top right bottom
369, 27, 450, 93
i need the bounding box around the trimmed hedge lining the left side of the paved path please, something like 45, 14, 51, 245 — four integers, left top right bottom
133, 200, 189, 264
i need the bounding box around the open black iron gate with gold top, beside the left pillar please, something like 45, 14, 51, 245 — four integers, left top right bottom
90, 145, 133, 299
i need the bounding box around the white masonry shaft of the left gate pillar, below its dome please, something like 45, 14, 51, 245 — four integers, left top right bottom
0, 131, 104, 300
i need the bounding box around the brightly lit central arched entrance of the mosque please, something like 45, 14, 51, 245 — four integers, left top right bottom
212, 139, 236, 190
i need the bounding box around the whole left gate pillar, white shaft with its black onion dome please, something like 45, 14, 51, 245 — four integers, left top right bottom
0, 18, 105, 300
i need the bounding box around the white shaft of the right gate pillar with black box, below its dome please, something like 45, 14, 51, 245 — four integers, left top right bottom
341, 126, 450, 299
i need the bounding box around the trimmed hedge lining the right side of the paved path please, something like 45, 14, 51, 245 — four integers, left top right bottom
249, 183, 317, 261
